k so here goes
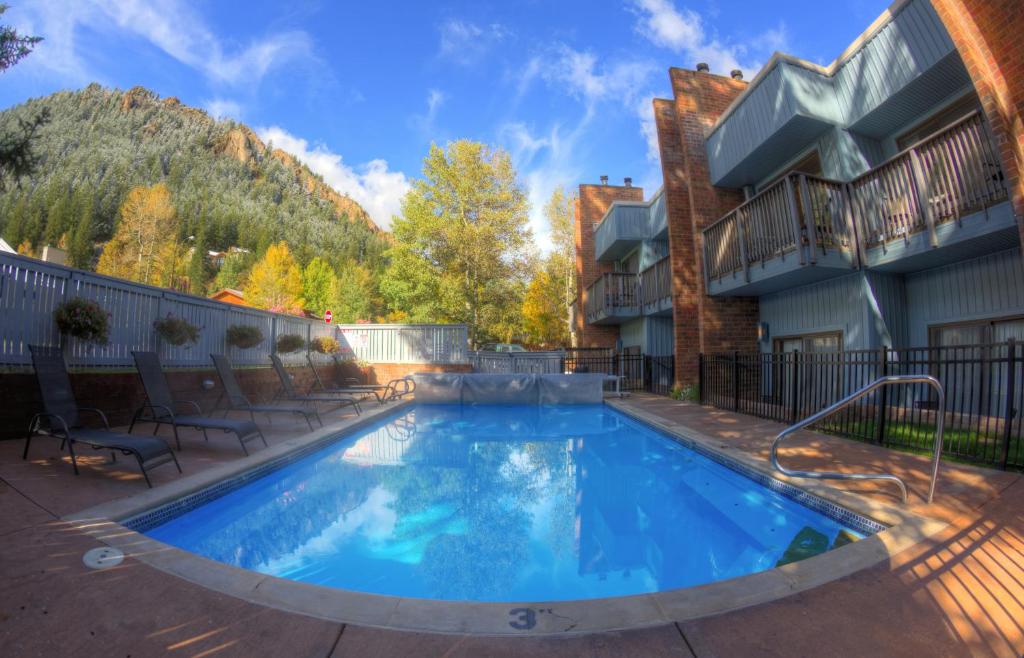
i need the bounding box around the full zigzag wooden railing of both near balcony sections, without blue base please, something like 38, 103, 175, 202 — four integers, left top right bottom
703, 113, 1007, 280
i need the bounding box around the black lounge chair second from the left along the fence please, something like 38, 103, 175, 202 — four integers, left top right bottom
128, 352, 267, 454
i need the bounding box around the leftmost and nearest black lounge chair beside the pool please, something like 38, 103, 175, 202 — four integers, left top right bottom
22, 345, 181, 488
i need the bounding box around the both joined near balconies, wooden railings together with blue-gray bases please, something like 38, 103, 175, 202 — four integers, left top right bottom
703, 113, 1018, 295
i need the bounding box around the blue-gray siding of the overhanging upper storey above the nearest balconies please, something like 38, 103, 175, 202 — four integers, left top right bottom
707, 0, 971, 187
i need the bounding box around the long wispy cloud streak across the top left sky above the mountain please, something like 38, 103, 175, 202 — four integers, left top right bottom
12, 0, 314, 87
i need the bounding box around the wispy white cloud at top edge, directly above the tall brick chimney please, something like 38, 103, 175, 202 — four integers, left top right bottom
632, 0, 787, 78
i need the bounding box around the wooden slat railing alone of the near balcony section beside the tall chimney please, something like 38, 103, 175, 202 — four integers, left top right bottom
703, 172, 853, 279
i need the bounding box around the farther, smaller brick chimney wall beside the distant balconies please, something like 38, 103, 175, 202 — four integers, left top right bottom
574, 184, 644, 347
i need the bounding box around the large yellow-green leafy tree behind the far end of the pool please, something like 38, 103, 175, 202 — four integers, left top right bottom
381, 140, 531, 345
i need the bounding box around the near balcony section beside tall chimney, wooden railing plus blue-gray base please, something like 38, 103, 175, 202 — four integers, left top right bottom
703, 173, 857, 296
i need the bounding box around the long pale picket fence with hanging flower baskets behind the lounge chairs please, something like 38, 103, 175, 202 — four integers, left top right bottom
0, 253, 468, 367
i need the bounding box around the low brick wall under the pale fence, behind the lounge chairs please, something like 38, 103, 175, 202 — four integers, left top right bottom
0, 363, 472, 440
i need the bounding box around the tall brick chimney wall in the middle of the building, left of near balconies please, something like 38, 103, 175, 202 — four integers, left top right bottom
653, 69, 758, 385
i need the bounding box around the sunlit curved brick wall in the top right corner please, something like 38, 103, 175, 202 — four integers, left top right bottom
932, 0, 1024, 238
